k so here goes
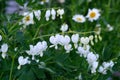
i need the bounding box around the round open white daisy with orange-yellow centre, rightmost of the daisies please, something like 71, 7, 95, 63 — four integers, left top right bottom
86, 8, 101, 22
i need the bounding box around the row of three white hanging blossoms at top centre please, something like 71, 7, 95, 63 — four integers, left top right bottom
45, 8, 64, 21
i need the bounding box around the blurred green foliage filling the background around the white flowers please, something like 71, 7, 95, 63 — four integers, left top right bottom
0, 0, 120, 80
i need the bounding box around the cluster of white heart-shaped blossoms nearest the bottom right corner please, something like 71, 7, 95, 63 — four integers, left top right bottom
98, 61, 114, 74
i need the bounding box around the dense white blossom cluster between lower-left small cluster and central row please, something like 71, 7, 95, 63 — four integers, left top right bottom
26, 41, 47, 60
